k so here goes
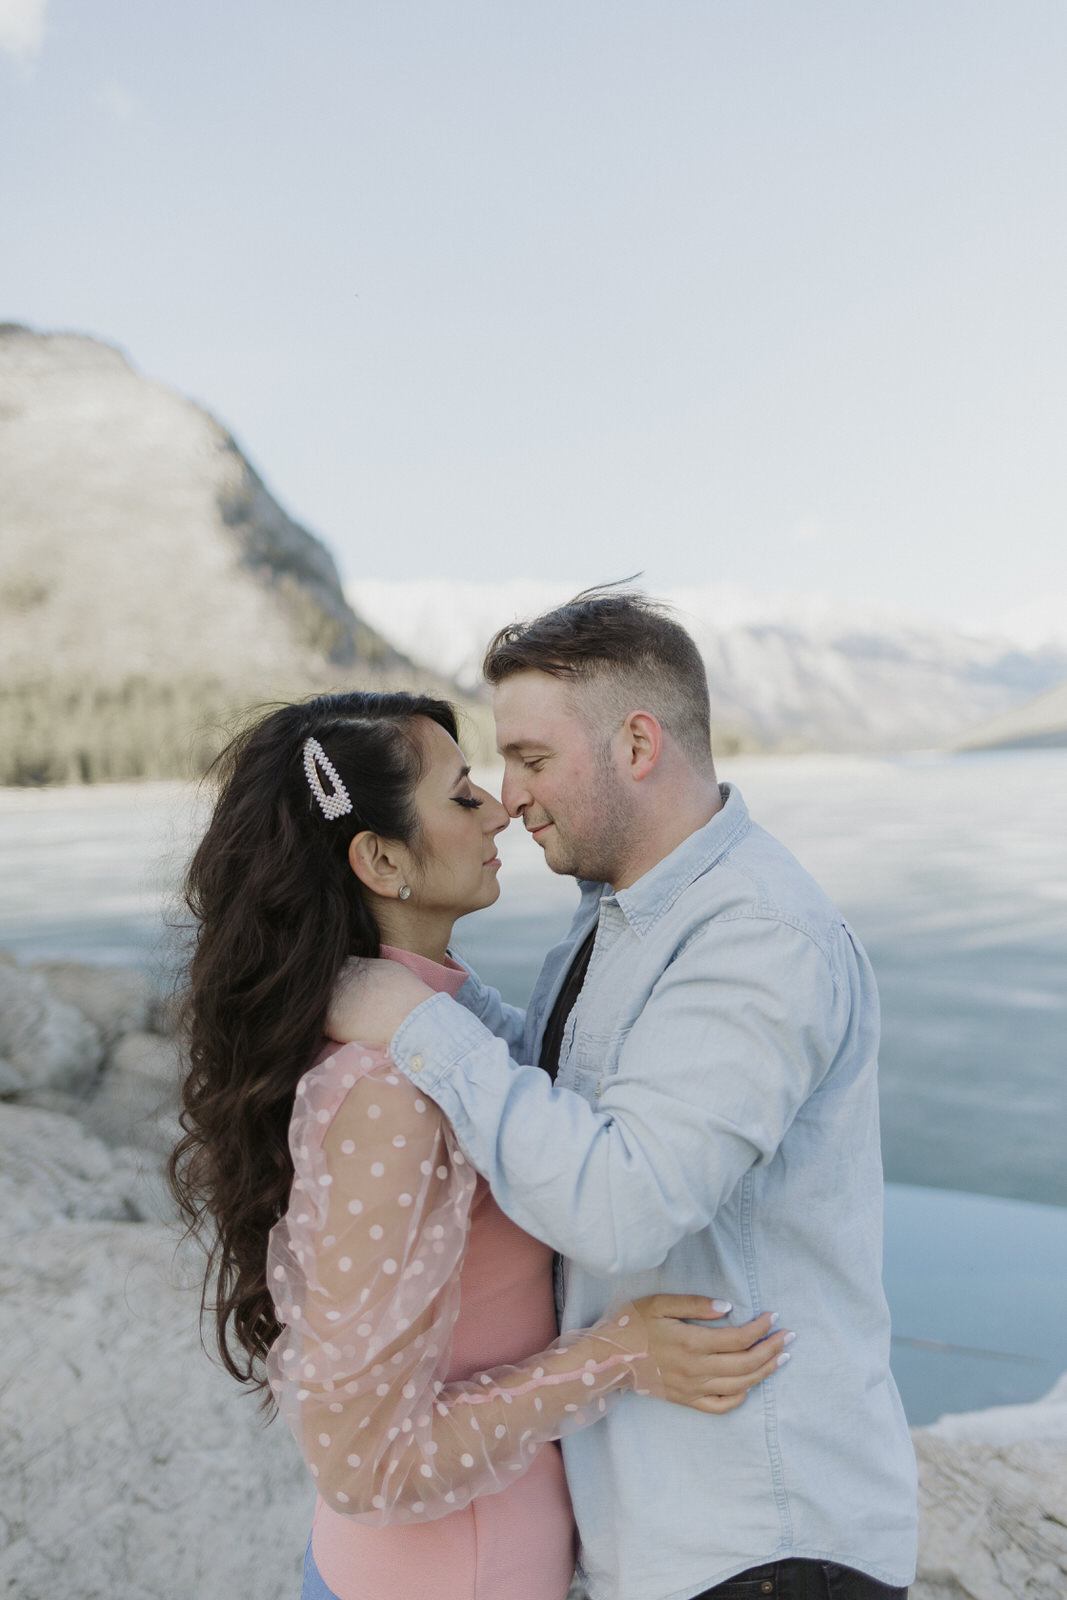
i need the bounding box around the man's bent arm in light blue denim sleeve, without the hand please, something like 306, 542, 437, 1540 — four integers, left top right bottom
392, 917, 848, 1275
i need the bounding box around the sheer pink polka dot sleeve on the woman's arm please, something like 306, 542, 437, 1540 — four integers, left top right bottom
267, 1045, 657, 1526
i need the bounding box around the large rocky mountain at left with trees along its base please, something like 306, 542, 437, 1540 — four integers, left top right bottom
0, 325, 467, 784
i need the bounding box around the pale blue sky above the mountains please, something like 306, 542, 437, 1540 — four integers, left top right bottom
0, 0, 1067, 636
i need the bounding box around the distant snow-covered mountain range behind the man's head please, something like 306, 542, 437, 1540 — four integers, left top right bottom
347, 578, 1067, 750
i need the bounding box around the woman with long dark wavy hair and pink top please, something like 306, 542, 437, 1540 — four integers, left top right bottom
171, 693, 784, 1600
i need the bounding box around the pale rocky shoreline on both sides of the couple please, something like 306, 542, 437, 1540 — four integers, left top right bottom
0, 952, 1067, 1600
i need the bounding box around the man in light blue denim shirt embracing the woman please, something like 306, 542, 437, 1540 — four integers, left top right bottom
334, 590, 915, 1600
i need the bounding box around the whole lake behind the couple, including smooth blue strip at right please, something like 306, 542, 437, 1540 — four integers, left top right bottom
0, 750, 1067, 1421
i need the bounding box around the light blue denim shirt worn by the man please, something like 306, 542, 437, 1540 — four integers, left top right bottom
392, 786, 917, 1600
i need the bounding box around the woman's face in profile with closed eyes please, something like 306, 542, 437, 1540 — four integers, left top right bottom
411, 717, 509, 917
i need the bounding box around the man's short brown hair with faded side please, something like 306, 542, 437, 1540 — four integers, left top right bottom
482, 586, 712, 766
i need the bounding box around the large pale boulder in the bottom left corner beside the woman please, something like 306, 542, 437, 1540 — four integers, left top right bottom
0, 1222, 314, 1600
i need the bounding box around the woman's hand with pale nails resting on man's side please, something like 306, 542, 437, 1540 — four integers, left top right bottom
627, 1294, 795, 1413
